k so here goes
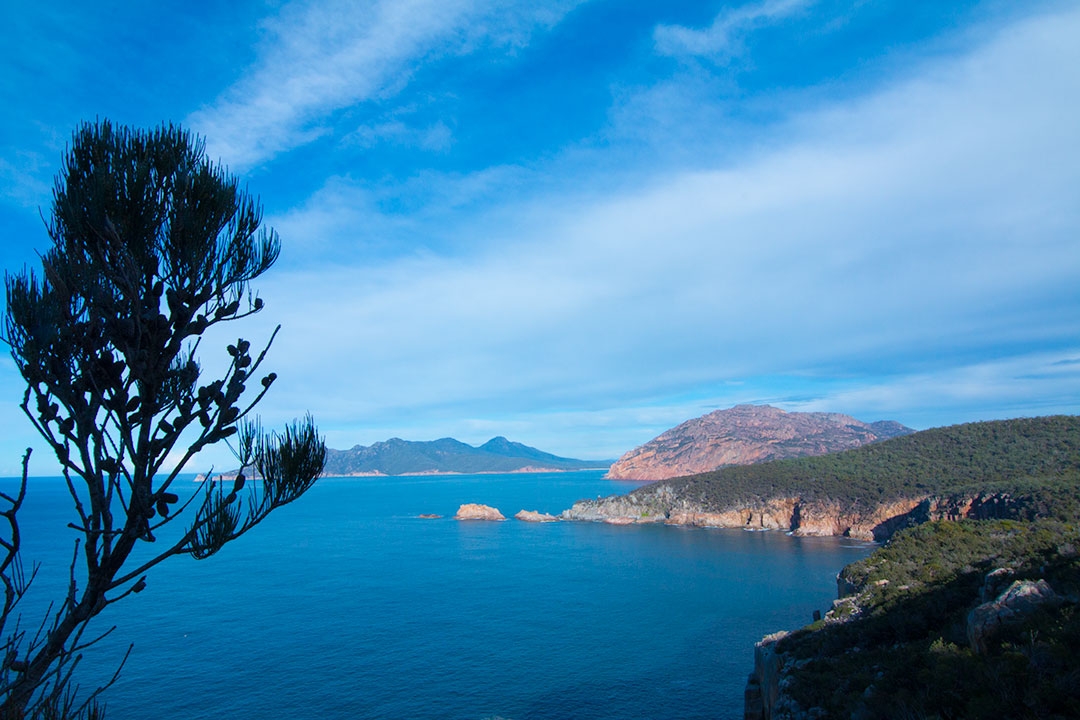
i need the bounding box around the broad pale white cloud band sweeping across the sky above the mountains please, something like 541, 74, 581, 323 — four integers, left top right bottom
243, 4, 1080, 451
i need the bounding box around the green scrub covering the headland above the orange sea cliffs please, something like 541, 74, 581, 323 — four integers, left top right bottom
656, 416, 1080, 509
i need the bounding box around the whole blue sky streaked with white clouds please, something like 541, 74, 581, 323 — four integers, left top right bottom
0, 0, 1080, 475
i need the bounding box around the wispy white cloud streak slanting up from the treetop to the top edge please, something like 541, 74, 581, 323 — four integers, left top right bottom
187, 0, 576, 169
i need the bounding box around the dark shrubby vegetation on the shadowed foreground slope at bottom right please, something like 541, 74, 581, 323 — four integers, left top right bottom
778, 520, 1080, 720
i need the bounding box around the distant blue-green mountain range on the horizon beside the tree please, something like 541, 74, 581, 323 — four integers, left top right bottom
323, 436, 611, 476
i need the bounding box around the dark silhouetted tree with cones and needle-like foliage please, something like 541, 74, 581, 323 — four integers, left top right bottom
0, 121, 325, 718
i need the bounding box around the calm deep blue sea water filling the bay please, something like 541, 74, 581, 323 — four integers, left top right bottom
2, 471, 872, 720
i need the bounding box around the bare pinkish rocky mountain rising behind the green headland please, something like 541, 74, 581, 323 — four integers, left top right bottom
608, 405, 914, 480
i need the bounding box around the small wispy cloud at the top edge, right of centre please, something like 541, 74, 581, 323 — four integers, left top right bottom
654, 0, 814, 59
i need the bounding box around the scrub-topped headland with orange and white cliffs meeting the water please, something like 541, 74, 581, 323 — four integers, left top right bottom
563, 416, 1080, 541
